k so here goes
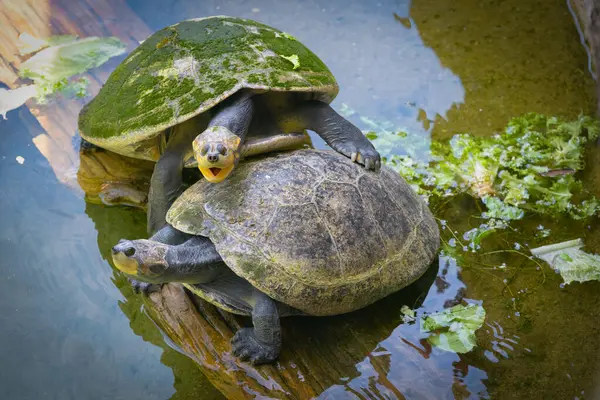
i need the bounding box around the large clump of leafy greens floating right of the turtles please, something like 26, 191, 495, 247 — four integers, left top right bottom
386, 113, 600, 221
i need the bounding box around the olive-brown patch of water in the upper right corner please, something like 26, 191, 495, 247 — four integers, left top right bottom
410, 0, 595, 138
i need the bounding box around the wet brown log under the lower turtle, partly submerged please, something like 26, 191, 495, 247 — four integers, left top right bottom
145, 265, 441, 399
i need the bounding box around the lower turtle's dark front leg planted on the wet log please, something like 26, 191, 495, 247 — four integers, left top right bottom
231, 288, 281, 365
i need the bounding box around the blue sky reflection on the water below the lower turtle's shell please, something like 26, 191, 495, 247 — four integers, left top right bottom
319, 257, 488, 399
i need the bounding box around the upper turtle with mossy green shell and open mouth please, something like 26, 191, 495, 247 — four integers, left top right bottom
78, 16, 381, 238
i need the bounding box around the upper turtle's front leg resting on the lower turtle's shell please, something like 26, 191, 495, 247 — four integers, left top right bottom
281, 100, 381, 171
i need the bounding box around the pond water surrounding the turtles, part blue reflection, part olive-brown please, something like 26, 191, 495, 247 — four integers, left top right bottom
0, 0, 600, 399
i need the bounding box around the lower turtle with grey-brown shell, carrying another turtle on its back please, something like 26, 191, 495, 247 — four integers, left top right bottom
112, 149, 440, 364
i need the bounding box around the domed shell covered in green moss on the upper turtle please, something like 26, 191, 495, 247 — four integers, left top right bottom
79, 16, 339, 160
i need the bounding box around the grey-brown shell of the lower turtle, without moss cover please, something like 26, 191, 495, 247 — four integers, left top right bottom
167, 150, 439, 315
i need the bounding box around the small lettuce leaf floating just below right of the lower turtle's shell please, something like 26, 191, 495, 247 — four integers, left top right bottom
421, 304, 485, 353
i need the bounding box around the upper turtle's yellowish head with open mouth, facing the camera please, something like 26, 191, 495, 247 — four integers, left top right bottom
192, 126, 242, 183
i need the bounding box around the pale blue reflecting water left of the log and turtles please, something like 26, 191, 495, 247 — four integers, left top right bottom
0, 98, 219, 399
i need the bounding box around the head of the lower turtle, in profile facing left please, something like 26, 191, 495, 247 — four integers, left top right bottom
112, 239, 169, 283
